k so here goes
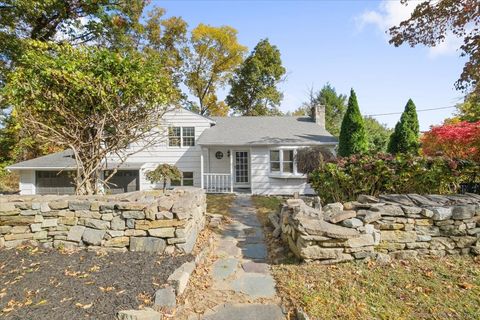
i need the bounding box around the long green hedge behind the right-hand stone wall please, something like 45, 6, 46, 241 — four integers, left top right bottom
309, 153, 480, 203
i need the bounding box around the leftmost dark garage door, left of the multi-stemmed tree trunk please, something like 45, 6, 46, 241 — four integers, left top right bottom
35, 171, 75, 194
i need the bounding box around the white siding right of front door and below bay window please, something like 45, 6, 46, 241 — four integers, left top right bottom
250, 147, 332, 195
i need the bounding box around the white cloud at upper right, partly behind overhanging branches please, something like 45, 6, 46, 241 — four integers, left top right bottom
356, 0, 461, 58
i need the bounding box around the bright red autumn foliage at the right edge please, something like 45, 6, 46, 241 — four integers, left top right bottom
421, 121, 480, 161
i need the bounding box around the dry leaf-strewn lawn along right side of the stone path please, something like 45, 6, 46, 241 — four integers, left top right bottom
249, 197, 480, 319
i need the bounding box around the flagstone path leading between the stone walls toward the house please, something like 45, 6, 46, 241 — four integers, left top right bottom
189, 195, 284, 320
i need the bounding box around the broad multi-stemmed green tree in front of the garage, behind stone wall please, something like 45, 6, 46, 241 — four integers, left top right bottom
0, 41, 175, 194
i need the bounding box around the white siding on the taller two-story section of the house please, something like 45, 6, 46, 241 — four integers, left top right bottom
113, 109, 211, 190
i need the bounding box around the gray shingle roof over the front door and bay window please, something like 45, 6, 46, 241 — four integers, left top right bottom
198, 116, 338, 146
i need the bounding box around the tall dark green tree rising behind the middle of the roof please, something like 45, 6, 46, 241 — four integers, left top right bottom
225, 39, 285, 116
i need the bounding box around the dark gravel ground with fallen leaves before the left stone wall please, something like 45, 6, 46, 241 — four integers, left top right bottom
0, 247, 192, 320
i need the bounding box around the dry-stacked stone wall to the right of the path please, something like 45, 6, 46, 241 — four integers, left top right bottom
276, 194, 480, 264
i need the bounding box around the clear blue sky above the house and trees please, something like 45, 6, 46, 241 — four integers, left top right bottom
152, 0, 464, 130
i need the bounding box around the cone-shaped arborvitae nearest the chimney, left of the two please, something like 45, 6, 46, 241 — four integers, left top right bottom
338, 89, 368, 157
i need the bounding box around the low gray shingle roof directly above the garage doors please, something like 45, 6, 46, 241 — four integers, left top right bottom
7, 150, 144, 170
